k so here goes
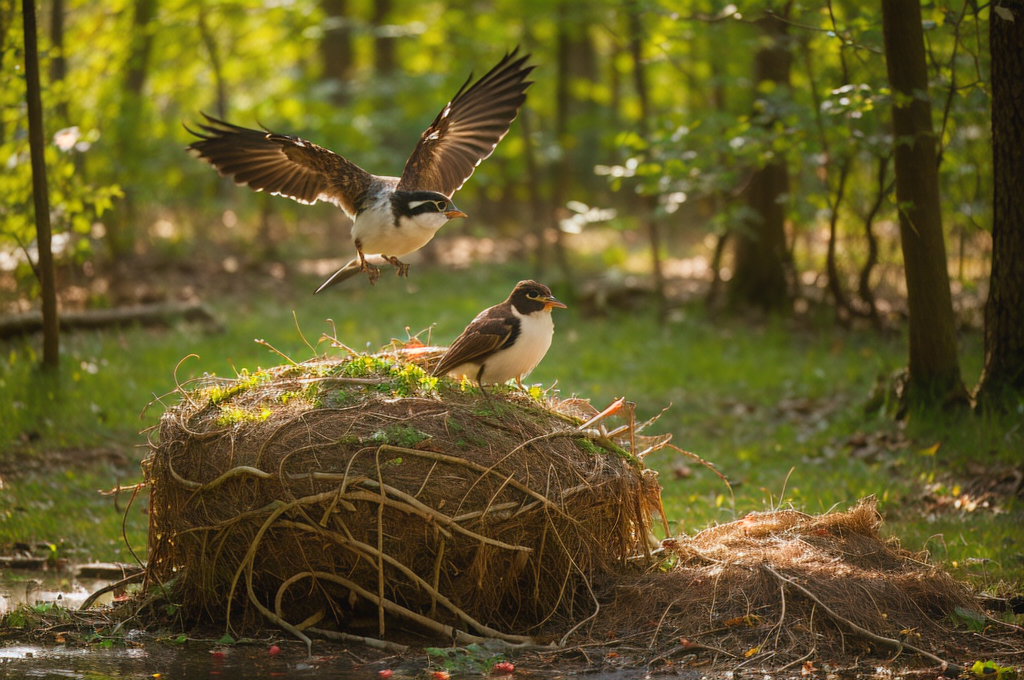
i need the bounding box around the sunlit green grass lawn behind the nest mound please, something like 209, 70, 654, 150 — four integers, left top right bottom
0, 260, 1024, 588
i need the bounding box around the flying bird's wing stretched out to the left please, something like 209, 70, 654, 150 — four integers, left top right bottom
185, 114, 373, 218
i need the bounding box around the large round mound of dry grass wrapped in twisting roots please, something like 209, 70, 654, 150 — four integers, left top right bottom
143, 349, 665, 642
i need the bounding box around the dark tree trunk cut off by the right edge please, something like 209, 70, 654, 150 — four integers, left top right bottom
978, 0, 1024, 407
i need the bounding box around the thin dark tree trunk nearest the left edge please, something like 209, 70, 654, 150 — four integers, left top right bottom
22, 0, 60, 371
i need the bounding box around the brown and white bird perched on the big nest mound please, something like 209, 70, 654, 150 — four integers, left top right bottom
433, 281, 565, 394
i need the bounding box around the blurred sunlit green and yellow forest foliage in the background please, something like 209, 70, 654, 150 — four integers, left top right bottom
0, 0, 1007, 401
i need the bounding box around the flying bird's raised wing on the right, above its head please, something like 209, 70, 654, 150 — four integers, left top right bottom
398, 47, 534, 198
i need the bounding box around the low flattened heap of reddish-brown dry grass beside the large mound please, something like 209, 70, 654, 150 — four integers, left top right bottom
603, 499, 985, 670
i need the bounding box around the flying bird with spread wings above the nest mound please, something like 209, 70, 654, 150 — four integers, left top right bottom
185, 47, 534, 293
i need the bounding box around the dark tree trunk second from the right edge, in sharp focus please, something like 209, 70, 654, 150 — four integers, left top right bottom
882, 0, 968, 406
